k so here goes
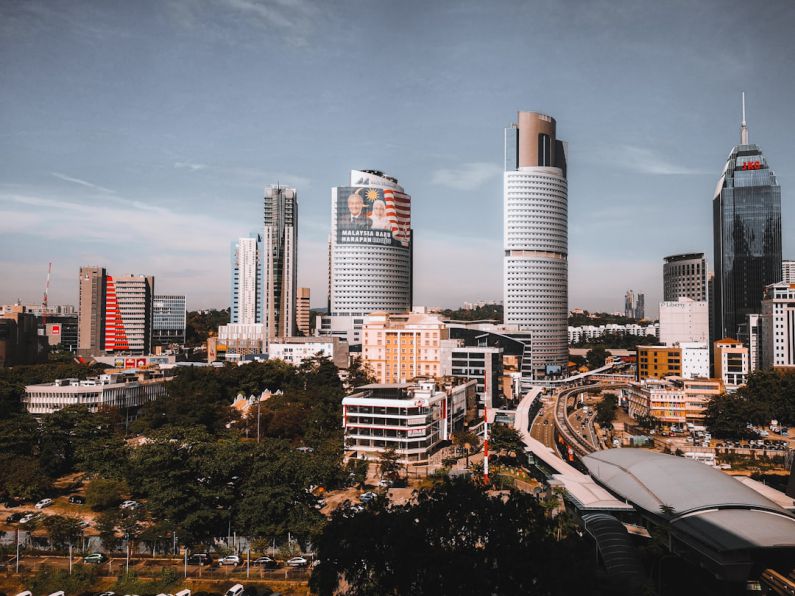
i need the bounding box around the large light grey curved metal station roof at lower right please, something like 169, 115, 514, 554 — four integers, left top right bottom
583, 449, 790, 518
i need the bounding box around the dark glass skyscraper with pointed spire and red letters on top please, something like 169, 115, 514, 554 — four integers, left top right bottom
712, 95, 782, 339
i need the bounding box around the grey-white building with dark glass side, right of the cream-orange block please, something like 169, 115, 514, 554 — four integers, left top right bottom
440, 339, 504, 408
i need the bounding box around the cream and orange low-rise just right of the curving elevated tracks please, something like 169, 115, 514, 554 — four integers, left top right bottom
627, 378, 723, 430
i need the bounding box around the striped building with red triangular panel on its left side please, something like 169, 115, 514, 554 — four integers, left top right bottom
105, 275, 155, 355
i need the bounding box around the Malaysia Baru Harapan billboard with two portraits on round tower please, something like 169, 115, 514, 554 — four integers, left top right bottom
337, 186, 411, 248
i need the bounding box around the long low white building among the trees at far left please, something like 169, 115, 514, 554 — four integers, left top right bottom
22, 371, 169, 418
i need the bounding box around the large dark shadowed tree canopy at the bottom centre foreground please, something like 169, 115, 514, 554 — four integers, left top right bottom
310, 478, 600, 596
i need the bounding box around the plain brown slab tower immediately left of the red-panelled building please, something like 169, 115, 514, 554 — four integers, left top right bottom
77, 267, 107, 355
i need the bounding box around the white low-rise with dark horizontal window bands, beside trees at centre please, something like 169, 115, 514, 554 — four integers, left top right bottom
342, 380, 476, 465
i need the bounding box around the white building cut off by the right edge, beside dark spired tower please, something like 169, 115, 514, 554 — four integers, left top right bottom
761, 282, 795, 370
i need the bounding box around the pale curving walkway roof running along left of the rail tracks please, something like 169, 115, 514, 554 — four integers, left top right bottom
513, 387, 632, 512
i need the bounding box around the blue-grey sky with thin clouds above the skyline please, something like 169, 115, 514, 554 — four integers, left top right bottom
0, 0, 795, 314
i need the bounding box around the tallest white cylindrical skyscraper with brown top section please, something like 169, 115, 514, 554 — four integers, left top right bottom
503, 112, 568, 378
